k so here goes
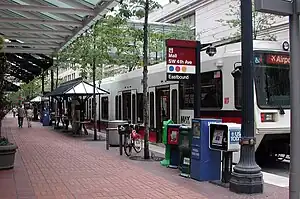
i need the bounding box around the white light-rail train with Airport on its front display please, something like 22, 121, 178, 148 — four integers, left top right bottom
97, 41, 290, 163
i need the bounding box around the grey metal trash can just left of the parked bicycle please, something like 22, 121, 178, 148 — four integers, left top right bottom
106, 120, 128, 147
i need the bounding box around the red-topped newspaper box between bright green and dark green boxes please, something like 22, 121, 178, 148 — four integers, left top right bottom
167, 124, 181, 169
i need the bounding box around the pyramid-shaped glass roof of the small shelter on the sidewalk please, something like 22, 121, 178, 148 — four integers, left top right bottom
45, 78, 109, 97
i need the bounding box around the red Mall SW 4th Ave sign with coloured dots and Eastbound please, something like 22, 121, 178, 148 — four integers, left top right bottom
166, 39, 196, 81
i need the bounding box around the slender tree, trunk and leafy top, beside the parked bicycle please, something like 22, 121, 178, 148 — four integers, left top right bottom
120, 0, 178, 159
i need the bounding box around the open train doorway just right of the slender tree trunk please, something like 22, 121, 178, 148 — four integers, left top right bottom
156, 86, 170, 142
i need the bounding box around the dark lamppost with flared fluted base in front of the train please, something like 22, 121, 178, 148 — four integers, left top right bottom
229, 0, 263, 194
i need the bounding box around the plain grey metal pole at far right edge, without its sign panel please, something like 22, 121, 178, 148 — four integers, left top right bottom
289, 0, 300, 199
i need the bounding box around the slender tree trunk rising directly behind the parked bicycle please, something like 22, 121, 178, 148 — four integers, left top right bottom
143, 0, 150, 159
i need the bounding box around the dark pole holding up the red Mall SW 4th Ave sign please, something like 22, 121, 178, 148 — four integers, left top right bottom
194, 41, 201, 118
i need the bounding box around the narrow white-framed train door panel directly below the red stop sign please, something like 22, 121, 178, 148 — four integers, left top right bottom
169, 84, 179, 124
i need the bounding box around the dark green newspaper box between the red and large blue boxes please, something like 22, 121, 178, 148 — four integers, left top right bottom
179, 126, 192, 177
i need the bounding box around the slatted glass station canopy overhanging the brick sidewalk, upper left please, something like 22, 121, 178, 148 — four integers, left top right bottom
0, 0, 117, 82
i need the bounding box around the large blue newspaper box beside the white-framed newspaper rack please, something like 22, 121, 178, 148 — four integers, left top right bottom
190, 119, 222, 181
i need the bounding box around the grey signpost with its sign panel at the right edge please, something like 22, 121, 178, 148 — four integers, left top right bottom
255, 0, 300, 199
